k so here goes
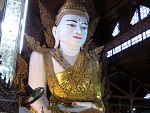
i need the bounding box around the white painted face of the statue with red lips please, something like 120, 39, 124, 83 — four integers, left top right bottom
53, 14, 88, 48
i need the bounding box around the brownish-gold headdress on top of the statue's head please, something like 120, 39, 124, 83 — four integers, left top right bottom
55, 0, 89, 25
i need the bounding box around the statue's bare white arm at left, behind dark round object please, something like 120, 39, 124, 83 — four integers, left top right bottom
28, 51, 50, 113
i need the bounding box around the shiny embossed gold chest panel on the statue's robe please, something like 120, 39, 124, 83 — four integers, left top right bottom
56, 69, 92, 92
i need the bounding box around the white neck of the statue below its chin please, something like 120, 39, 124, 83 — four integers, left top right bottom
59, 42, 80, 56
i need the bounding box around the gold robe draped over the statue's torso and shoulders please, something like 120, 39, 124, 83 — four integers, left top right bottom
43, 50, 104, 109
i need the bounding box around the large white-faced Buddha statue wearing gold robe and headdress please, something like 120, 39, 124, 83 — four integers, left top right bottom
28, 0, 104, 113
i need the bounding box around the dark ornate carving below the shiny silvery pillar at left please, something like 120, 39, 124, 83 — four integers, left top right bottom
0, 73, 19, 113
